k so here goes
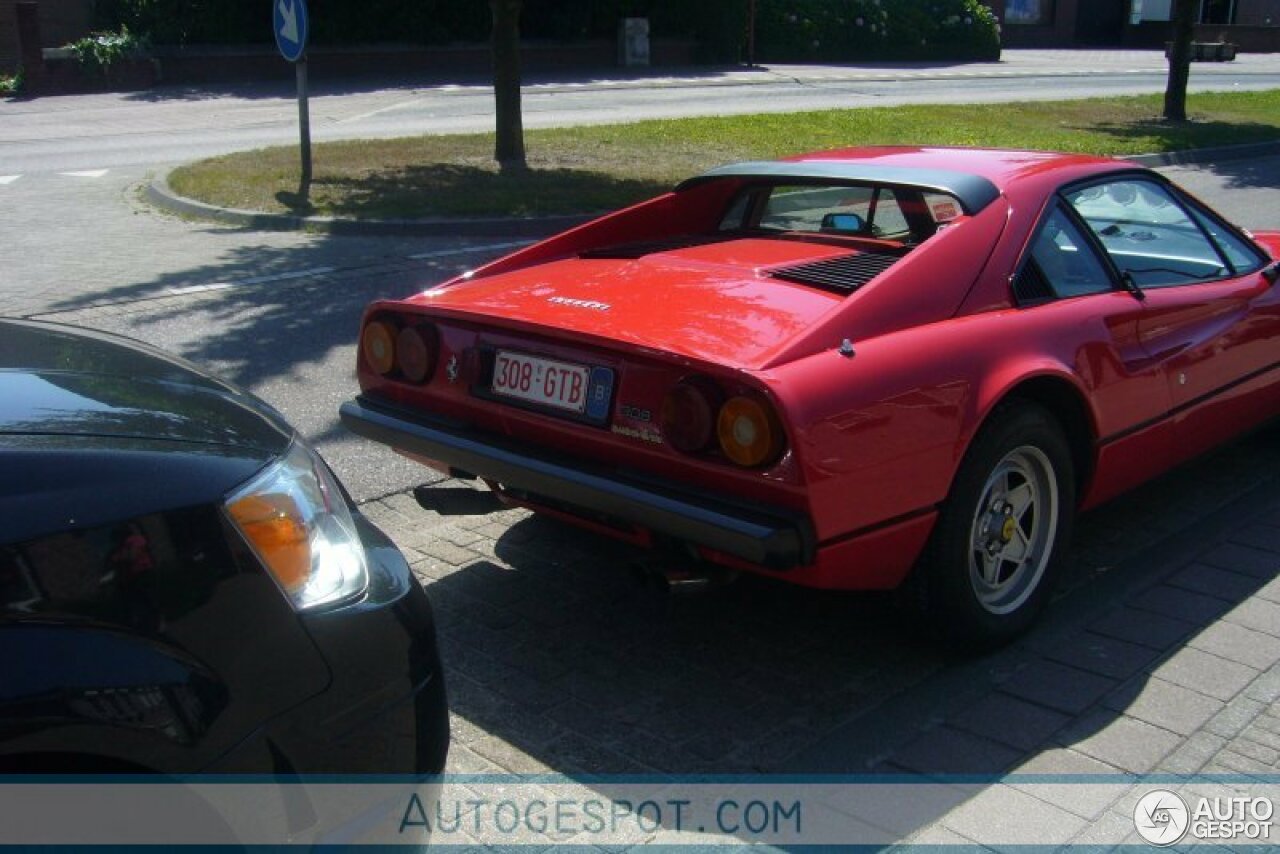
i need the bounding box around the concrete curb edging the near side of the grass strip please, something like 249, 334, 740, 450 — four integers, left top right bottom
152, 141, 1280, 237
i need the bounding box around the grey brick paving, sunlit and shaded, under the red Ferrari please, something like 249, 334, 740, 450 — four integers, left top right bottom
365, 414, 1280, 844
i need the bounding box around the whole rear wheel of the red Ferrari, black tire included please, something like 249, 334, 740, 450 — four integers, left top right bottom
918, 401, 1075, 648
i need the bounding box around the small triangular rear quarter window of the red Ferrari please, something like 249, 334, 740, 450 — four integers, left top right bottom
1014, 207, 1111, 301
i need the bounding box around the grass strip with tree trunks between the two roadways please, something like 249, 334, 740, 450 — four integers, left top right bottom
169, 90, 1280, 219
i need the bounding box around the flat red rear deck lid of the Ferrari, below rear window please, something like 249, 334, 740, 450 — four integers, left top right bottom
411, 238, 888, 367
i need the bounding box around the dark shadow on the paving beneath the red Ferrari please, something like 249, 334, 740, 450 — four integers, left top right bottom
412, 428, 1280, 835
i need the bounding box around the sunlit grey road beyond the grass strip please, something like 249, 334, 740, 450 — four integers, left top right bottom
0, 50, 1280, 175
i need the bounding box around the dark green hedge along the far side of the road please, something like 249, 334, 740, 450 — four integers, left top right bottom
96, 0, 1000, 61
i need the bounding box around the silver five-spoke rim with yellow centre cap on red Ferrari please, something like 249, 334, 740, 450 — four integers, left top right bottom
969, 446, 1059, 615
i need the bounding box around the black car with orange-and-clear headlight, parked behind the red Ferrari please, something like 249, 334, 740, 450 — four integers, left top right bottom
0, 320, 448, 773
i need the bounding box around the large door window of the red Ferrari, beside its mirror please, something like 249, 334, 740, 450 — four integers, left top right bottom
1066, 178, 1230, 288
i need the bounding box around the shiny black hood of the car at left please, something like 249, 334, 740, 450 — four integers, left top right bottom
0, 320, 293, 543
